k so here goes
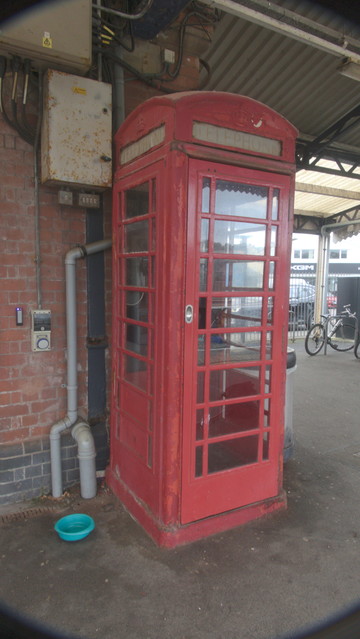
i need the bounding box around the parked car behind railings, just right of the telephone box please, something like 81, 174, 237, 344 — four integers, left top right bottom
289, 279, 315, 329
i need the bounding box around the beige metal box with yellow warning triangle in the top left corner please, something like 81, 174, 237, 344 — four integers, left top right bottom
0, 0, 92, 73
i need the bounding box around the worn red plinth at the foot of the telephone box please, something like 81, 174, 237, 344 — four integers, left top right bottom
106, 468, 287, 548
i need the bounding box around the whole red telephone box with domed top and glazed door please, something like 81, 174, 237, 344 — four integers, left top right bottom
107, 92, 297, 547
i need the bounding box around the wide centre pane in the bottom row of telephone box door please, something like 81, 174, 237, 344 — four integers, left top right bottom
208, 435, 258, 474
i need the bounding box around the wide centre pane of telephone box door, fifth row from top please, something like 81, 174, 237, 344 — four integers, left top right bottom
210, 332, 261, 364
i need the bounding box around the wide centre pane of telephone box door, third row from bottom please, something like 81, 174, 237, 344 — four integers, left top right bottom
210, 366, 260, 402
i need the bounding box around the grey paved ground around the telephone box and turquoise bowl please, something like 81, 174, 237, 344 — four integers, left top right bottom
0, 342, 360, 639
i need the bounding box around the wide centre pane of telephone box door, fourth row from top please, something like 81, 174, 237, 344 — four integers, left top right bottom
211, 297, 263, 328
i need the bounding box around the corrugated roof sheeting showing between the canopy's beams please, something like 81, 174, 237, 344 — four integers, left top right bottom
203, 0, 360, 226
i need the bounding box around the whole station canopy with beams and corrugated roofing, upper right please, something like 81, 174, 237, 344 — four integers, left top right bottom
202, 0, 360, 239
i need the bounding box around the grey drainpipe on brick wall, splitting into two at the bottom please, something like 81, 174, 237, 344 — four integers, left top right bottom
50, 240, 111, 499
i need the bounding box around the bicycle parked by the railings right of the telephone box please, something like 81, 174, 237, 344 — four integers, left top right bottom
305, 304, 360, 358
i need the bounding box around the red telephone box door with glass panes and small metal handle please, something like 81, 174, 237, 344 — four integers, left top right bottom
181, 160, 291, 524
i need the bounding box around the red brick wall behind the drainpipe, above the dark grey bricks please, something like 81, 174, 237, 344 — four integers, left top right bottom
0, 117, 86, 444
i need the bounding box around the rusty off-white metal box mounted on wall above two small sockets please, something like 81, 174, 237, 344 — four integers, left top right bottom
41, 70, 112, 189
